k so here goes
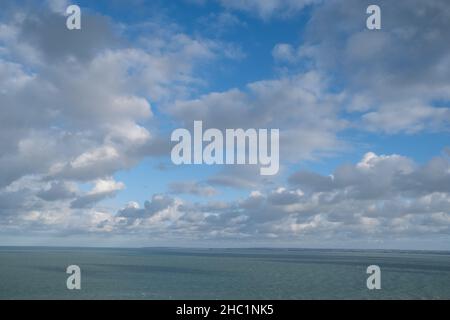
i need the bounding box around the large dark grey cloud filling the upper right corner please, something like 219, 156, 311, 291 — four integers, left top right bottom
294, 0, 450, 134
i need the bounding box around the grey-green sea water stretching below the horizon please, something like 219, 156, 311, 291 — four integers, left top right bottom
0, 247, 450, 299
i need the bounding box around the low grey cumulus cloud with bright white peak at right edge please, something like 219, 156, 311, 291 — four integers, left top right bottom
289, 152, 450, 199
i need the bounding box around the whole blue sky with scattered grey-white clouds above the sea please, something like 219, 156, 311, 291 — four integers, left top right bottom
0, 0, 450, 250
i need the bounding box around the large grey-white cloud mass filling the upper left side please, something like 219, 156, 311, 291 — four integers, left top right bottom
0, 2, 237, 187
